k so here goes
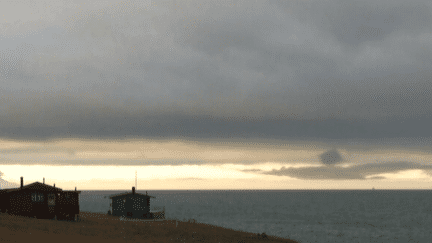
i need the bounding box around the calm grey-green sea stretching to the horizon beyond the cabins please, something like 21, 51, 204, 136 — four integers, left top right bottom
80, 190, 432, 243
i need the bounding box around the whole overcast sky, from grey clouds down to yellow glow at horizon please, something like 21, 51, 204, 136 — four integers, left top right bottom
0, 0, 432, 189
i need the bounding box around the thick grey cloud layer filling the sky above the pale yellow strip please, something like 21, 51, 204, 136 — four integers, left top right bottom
0, 0, 432, 139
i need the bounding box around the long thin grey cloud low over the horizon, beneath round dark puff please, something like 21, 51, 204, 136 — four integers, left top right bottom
261, 161, 432, 180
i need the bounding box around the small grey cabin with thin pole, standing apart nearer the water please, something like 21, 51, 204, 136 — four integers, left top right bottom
109, 187, 155, 218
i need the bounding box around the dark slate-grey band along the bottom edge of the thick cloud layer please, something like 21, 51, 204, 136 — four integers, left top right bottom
0, 109, 432, 140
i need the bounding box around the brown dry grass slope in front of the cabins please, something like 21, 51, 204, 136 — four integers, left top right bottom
0, 212, 295, 243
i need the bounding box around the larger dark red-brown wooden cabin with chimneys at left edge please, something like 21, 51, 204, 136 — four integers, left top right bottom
0, 177, 80, 220
